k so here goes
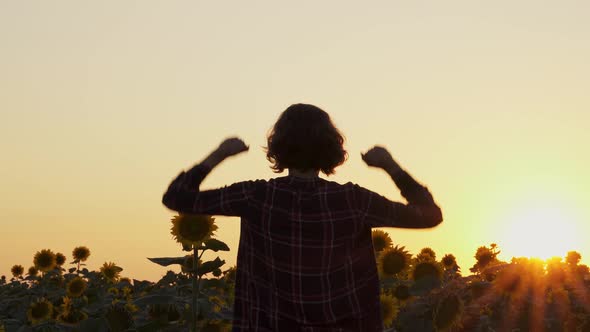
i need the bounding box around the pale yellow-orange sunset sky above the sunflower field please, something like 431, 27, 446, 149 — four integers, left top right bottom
0, 0, 590, 280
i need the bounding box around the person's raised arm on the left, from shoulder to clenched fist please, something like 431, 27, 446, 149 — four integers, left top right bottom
162, 138, 254, 216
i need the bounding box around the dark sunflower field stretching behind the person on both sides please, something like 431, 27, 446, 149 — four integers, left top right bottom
0, 215, 590, 332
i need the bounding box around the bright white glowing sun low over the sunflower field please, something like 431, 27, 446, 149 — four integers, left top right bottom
498, 203, 582, 260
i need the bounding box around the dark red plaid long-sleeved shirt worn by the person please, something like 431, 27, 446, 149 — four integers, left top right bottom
163, 165, 442, 332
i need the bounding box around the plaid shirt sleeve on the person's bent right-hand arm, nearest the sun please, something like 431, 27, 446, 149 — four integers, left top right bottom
355, 171, 442, 228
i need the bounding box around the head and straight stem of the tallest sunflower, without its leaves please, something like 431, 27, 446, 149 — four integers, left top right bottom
171, 214, 217, 331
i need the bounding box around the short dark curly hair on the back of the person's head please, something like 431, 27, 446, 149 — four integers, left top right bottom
265, 104, 347, 175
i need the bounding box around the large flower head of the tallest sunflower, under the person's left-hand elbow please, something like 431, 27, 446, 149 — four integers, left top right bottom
170, 214, 217, 246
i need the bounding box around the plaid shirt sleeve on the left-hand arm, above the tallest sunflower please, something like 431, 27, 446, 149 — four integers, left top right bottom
162, 165, 256, 216
